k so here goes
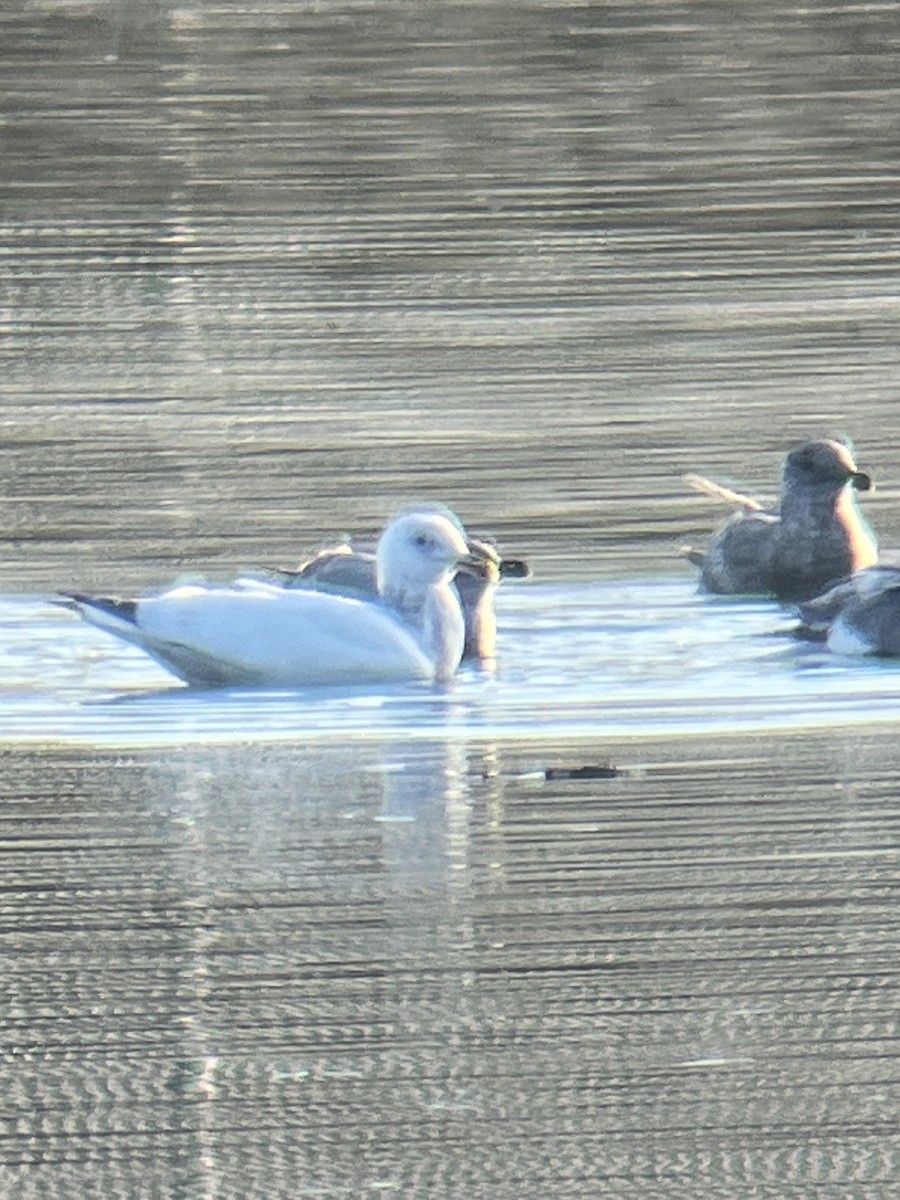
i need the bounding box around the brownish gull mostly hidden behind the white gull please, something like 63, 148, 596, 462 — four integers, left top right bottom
265, 530, 532, 662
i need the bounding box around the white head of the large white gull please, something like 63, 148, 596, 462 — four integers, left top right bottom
376, 512, 478, 604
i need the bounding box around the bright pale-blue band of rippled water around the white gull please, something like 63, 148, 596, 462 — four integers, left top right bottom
7, 580, 900, 745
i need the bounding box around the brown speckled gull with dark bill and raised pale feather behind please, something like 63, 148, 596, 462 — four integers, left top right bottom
685, 438, 877, 601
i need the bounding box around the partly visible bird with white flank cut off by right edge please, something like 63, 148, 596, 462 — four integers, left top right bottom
798, 565, 900, 656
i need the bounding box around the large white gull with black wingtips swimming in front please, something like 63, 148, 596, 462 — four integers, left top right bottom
65, 512, 489, 688
